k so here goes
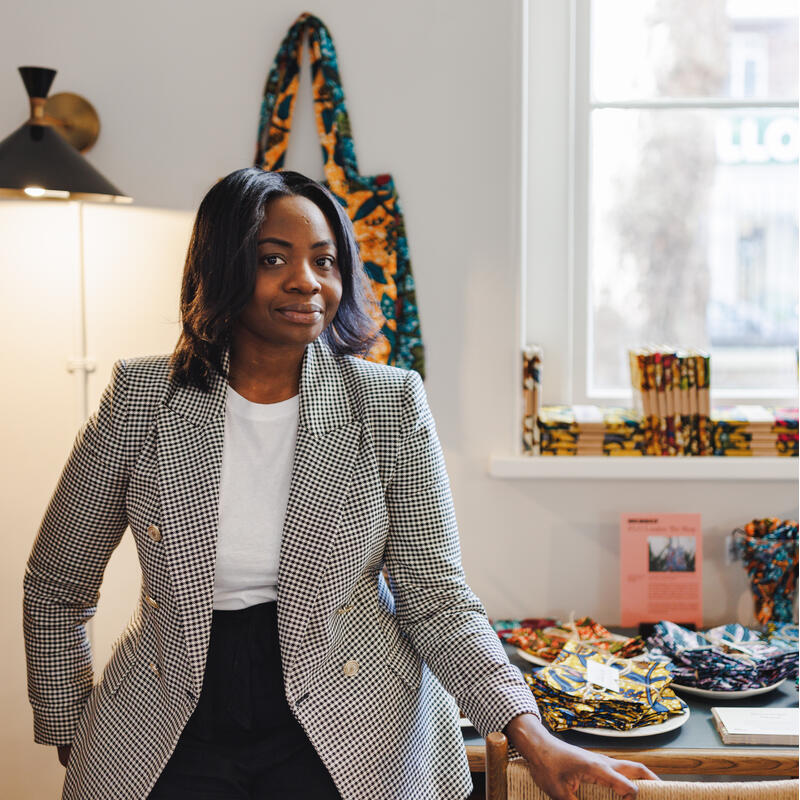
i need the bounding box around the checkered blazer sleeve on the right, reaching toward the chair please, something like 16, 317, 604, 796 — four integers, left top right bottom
386, 370, 539, 736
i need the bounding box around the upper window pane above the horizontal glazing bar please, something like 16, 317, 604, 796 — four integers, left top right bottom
591, 0, 800, 101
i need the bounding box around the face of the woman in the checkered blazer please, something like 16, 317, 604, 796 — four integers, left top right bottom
236, 196, 342, 348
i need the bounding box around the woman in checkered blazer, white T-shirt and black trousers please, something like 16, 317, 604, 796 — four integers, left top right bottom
25, 169, 654, 800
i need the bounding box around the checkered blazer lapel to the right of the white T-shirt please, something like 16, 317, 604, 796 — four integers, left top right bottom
278, 340, 362, 694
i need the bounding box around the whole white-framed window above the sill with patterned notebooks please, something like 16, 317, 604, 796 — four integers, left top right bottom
526, 0, 800, 404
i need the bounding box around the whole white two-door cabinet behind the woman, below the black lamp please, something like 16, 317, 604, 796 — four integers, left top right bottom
0, 201, 194, 800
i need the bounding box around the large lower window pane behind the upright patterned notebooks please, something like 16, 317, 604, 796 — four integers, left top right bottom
589, 108, 800, 395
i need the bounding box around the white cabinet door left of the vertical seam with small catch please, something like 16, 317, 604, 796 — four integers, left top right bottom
0, 201, 85, 800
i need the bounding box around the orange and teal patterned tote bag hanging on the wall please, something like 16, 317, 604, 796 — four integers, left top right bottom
255, 14, 425, 377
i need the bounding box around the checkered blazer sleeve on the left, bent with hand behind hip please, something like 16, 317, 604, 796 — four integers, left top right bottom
23, 361, 128, 745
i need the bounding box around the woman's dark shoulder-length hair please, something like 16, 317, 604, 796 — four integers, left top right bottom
170, 167, 380, 391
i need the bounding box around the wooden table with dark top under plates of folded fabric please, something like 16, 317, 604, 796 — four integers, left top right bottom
462, 645, 798, 778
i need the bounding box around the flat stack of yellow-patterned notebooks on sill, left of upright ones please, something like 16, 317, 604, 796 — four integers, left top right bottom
537, 405, 644, 456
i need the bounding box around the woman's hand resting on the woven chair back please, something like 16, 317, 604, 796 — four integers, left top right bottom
505, 714, 658, 800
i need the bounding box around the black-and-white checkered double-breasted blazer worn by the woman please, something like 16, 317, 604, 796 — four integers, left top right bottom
24, 340, 538, 800
